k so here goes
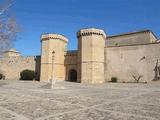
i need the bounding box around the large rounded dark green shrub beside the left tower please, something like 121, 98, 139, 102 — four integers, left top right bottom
20, 70, 35, 80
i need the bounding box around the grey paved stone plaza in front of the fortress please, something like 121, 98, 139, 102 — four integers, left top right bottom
0, 81, 160, 120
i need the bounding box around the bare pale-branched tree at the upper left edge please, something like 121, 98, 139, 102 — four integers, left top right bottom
0, 0, 19, 56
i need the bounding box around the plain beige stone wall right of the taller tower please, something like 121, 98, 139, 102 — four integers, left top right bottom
105, 43, 160, 82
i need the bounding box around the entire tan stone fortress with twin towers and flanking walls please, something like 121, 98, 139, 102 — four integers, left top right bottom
0, 28, 160, 84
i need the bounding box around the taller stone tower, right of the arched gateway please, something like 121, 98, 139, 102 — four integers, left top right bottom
77, 28, 106, 84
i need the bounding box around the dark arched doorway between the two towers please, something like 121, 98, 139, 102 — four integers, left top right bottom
68, 69, 77, 82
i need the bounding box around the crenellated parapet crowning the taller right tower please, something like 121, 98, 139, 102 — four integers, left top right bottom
77, 28, 106, 38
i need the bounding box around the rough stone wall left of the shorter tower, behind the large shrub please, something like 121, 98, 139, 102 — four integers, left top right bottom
0, 56, 40, 80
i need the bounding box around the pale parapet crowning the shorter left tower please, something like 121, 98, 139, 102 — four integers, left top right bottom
41, 34, 68, 42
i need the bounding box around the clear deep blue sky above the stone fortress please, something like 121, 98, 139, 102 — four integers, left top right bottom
3, 0, 160, 56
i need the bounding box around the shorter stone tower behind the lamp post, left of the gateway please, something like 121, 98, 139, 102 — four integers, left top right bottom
40, 34, 68, 82
